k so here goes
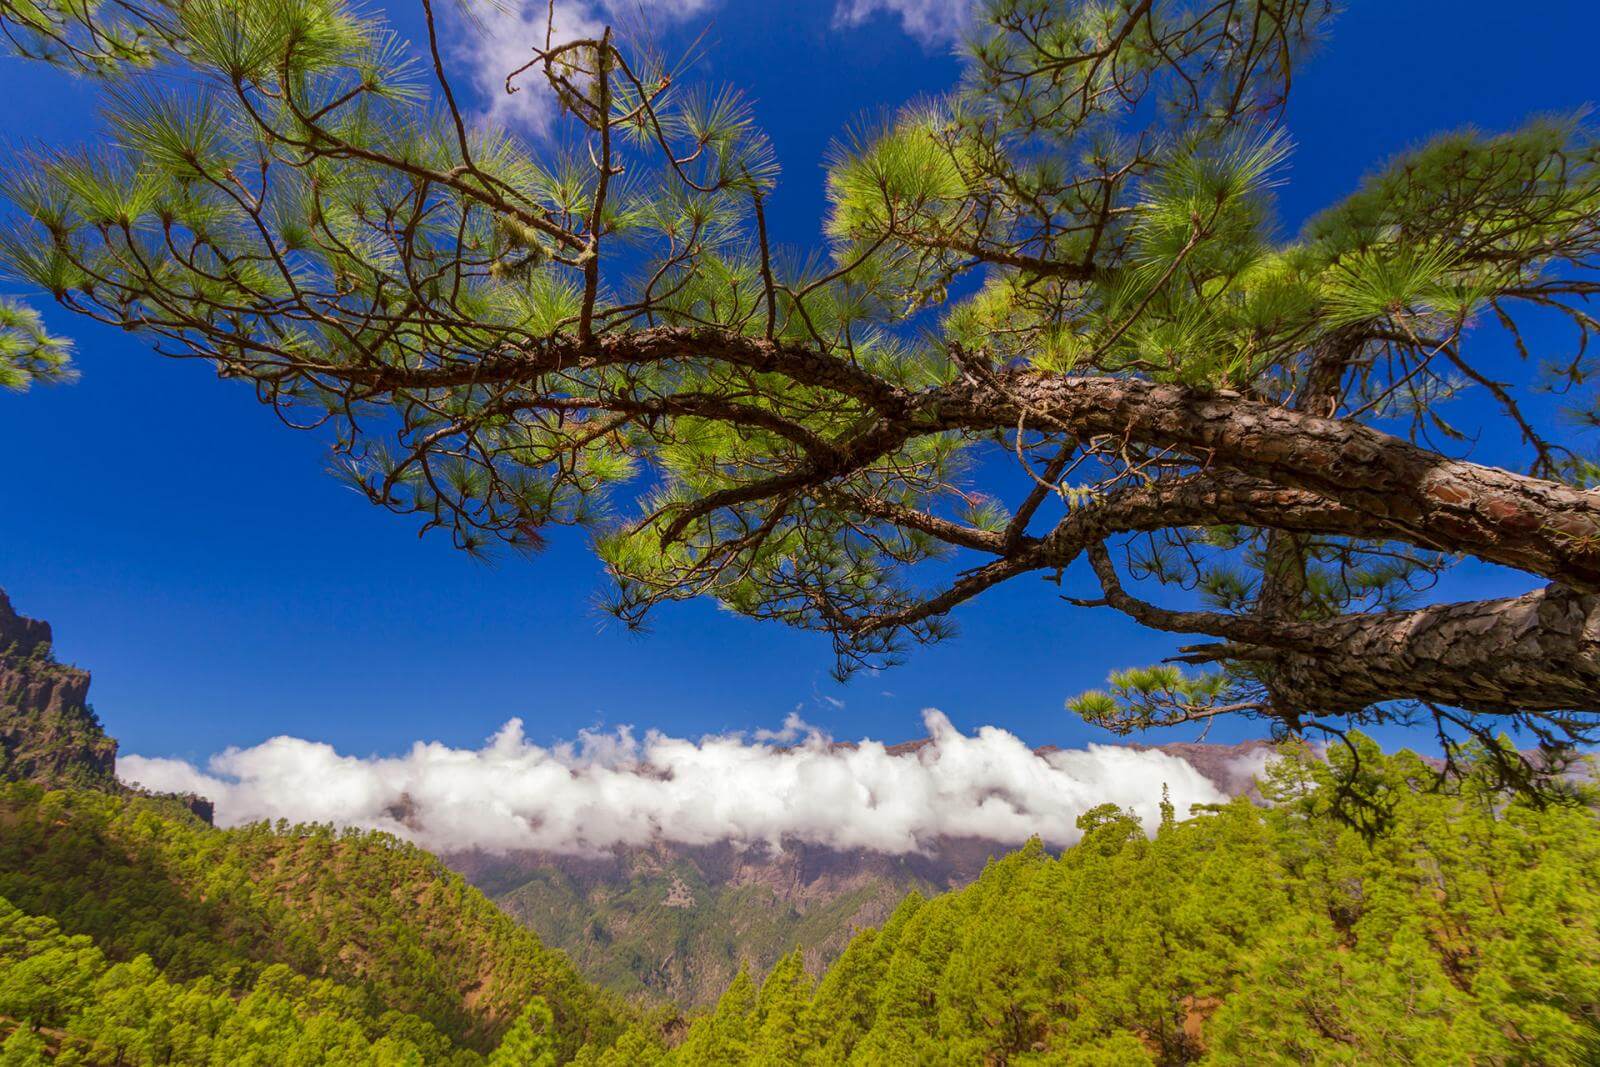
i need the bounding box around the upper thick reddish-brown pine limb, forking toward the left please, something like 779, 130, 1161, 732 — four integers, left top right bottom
360, 326, 1600, 592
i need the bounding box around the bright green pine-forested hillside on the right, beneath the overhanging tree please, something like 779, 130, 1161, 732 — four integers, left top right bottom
582, 741, 1600, 1065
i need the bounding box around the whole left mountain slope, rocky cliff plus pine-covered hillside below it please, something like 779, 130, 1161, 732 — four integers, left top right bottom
0, 593, 622, 1064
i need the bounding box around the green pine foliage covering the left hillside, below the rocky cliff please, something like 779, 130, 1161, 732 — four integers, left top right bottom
0, 784, 619, 1062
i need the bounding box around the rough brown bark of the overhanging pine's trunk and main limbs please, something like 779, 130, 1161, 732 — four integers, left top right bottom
196, 326, 1600, 723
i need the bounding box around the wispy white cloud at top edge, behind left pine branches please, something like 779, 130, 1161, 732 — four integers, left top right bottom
458, 0, 714, 134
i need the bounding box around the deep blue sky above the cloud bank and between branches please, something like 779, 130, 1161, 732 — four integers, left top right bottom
0, 0, 1600, 758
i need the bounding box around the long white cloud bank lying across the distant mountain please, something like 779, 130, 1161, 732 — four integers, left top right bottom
117, 709, 1226, 854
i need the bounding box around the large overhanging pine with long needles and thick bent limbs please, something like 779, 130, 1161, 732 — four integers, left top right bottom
0, 0, 1600, 787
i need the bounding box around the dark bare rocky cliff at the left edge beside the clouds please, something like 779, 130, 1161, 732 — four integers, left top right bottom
0, 590, 117, 789
